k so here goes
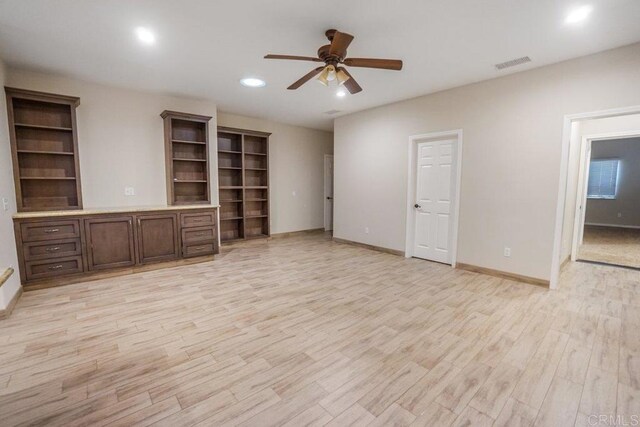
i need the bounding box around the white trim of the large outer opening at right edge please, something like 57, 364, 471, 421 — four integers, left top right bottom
549, 105, 640, 289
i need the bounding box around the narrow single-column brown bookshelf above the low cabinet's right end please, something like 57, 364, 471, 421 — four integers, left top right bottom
160, 110, 211, 205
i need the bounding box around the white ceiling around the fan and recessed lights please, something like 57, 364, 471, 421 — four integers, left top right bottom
0, 0, 640, 130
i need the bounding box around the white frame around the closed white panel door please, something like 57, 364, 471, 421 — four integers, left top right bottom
404, 129, 462, 268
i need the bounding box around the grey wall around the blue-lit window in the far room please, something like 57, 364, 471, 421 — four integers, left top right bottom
585, 138, 640, 227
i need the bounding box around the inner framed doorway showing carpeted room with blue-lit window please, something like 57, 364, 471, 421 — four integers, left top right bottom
571, 132, 640, 268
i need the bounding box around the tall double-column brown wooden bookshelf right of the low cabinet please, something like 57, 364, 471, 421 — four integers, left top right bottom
218, 127, 271, 242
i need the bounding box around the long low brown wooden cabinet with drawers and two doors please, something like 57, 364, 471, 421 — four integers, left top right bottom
14, 207, 218, 289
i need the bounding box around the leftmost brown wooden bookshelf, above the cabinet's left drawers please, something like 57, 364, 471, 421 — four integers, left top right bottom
5, 87, 82, 212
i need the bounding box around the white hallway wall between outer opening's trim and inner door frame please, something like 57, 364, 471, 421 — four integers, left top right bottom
560, 112, 640, 261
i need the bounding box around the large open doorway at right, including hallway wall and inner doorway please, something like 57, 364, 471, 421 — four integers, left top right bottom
551, 110, 640, 288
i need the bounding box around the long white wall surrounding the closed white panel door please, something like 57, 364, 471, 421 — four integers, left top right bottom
334, 44, 640, 280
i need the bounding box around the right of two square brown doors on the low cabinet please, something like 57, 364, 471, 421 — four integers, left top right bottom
138, 214, 180, 264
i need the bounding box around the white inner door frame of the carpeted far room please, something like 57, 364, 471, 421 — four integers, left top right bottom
571, 130, 640, 262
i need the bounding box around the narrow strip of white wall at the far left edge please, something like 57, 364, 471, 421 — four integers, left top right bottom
0, 61, 20, 310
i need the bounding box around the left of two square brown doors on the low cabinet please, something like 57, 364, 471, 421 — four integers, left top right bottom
84, 216, 136, 270
